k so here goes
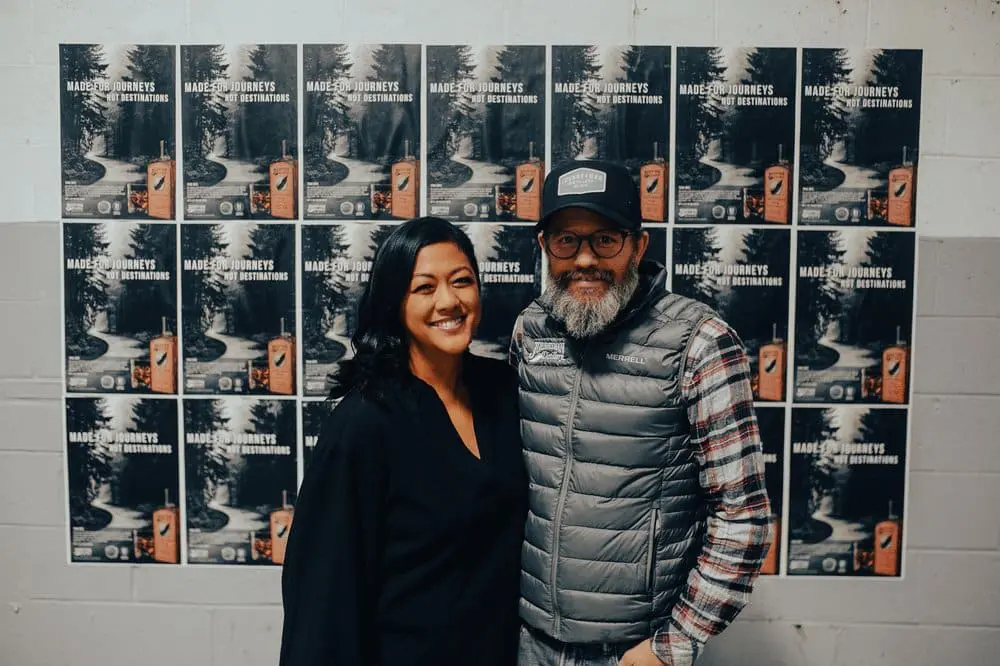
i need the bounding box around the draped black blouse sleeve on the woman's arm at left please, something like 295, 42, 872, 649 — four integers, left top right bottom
279, 394, 388, 666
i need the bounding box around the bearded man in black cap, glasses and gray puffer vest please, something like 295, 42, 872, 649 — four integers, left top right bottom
510, 161, 773, 666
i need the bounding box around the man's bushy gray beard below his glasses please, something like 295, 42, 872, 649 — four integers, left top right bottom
545, 262, 639, 340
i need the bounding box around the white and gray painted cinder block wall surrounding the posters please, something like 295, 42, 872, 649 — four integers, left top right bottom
0, 0, 1000, 666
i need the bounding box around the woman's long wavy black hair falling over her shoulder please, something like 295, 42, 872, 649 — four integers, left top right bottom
330, 217, 479, 399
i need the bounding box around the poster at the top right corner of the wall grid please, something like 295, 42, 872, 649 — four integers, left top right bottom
799, 48, 923, 227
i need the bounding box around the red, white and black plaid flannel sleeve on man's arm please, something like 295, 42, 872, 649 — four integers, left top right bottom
652, 318, 774, 666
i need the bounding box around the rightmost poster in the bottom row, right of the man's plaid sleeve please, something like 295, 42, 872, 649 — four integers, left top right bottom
788, 406, 907, 577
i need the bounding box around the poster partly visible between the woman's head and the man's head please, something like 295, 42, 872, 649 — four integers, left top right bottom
462, 224, 542, 361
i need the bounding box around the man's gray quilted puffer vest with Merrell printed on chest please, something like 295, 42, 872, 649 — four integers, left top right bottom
511, 261, 715, 643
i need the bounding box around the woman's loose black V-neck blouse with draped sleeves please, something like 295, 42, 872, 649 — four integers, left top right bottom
280, 355, 527, 666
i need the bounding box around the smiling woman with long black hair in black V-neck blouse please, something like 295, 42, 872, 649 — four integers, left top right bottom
280, 218, 527, 666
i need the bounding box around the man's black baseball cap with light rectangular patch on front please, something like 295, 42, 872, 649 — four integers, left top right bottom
536, 160, 642, 231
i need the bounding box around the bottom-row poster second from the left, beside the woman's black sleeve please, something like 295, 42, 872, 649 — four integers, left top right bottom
184, 396, 298, 565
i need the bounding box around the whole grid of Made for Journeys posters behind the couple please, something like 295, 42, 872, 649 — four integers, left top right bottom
59, 42, 923, 579
